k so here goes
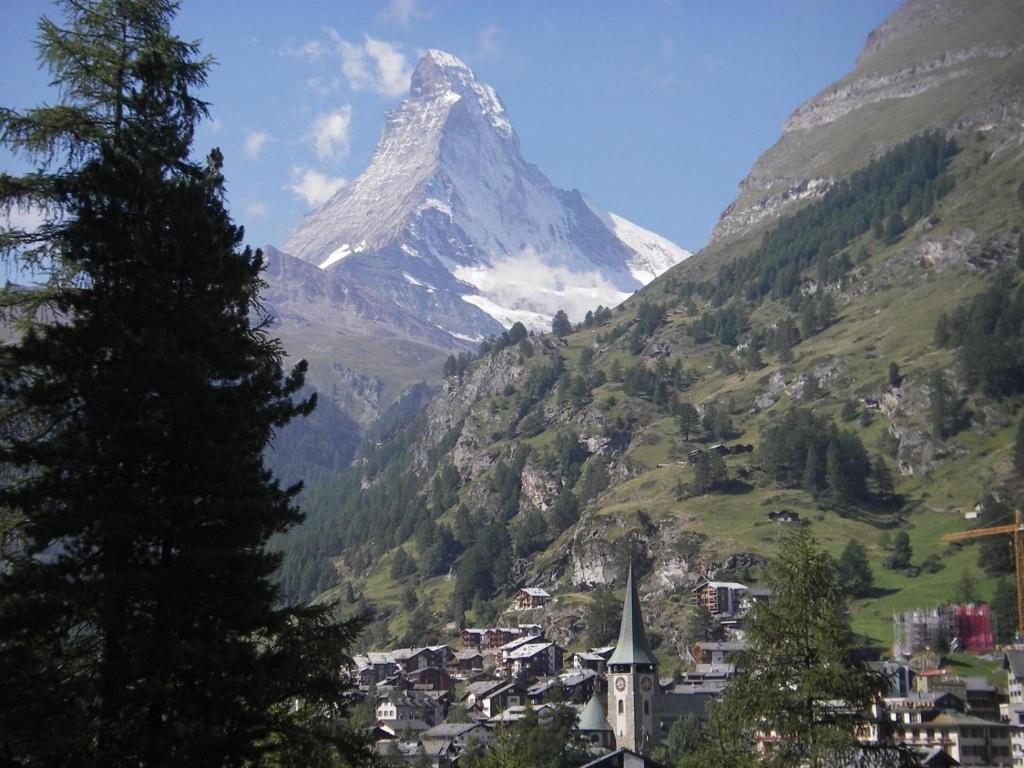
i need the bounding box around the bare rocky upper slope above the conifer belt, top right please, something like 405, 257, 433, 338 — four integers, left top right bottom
709, 0, 1024, 244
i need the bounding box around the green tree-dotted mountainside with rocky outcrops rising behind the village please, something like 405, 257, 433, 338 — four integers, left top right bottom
276, 2, 1024, 659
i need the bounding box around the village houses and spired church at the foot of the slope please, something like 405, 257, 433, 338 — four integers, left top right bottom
351, 573, 1024, 768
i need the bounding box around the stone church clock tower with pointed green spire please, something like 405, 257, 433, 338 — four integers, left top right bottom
608, 563, 659, 755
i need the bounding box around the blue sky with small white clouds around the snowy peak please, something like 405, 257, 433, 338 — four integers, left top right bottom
0, 0, 898, 256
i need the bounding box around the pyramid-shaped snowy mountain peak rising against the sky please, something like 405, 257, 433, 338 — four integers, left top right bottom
284, 50, 690, 338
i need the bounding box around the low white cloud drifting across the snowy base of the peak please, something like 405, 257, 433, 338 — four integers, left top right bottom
455, 248, 630, 321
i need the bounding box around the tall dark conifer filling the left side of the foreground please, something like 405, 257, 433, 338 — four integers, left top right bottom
0, 0, 360, 768
